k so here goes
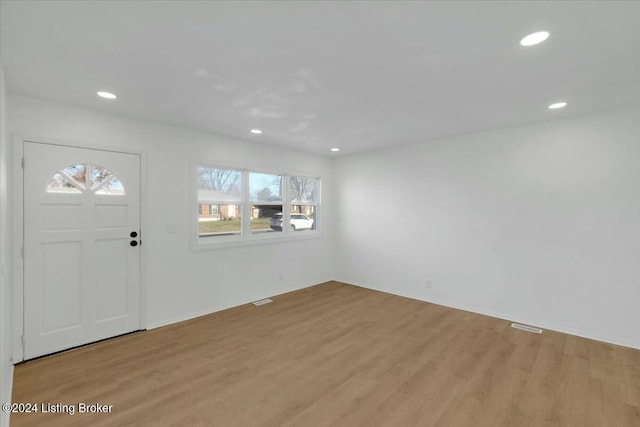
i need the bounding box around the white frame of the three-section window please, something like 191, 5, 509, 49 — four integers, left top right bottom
189, 163, 322, 251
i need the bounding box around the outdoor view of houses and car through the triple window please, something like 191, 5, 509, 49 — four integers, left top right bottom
196, 166, 320, 241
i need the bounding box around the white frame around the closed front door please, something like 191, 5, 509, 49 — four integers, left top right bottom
10, 135, 148, 364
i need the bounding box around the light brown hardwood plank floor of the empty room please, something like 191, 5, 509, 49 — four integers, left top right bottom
11, 282, 640, 427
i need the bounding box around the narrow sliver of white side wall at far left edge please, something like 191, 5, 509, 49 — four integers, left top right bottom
0, 62, 13, 426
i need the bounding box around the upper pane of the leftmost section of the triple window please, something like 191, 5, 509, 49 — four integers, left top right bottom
198, 167, 242, 204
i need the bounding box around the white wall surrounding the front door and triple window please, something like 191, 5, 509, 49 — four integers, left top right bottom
9, 96, 333, 336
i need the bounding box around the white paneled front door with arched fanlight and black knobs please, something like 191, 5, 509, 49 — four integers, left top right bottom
23, 142, 140, 359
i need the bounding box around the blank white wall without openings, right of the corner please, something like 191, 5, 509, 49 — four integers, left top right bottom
334, 109, 640, 348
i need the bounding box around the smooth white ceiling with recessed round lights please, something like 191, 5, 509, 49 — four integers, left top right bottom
0, 0, 640, 155
